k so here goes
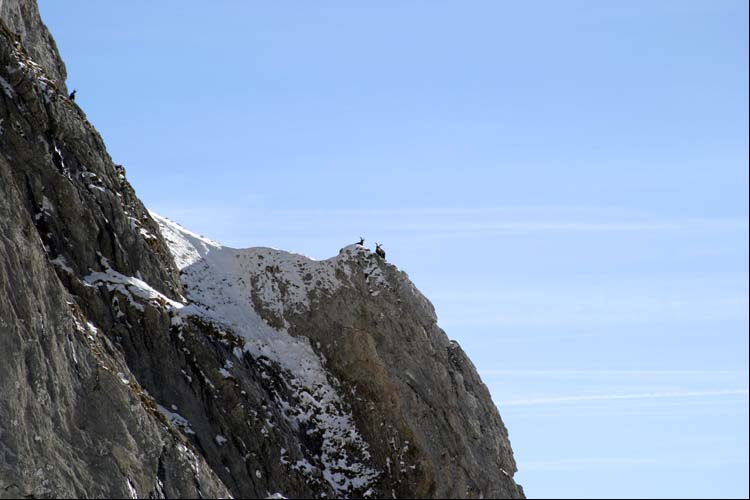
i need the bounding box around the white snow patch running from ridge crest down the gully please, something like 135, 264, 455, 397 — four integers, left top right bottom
151, 212, 384, 495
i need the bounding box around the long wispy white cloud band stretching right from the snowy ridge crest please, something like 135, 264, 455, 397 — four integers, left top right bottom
154, 203, 750, 246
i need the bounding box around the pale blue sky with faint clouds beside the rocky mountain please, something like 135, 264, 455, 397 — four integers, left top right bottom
40, 0, 748, 498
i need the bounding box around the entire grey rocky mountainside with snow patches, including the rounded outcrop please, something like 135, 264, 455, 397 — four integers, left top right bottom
0, 0, 523, 498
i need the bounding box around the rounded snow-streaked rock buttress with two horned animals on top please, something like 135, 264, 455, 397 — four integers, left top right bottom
151, 213, 520, 496
